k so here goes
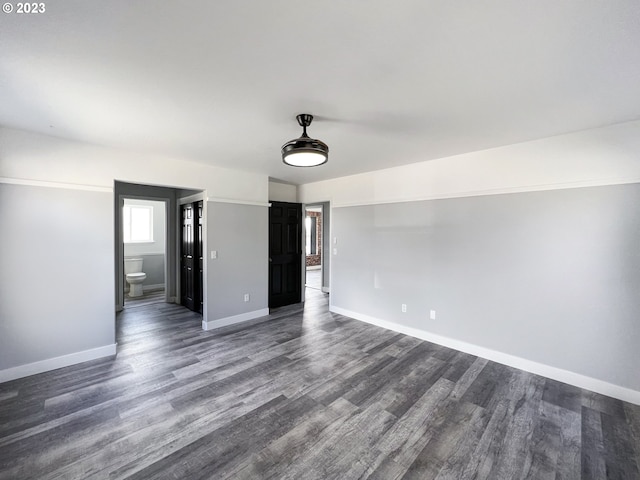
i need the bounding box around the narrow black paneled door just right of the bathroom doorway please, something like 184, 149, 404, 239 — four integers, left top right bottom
180, 204, 199, 311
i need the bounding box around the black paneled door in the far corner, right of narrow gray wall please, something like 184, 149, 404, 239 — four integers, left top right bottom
269, 202, 302, 308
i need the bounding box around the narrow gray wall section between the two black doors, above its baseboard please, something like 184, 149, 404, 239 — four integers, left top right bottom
206, 202, 269, 321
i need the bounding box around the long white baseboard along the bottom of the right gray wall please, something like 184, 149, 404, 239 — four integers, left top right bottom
329, 305, 640, 405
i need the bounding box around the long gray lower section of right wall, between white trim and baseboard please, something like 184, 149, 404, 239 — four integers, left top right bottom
331, 184, 640, 390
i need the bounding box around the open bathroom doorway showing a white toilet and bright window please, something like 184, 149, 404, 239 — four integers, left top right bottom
121, 197, 168, 308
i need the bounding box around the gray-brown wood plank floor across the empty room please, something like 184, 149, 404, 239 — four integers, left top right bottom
0, 289, 640, 480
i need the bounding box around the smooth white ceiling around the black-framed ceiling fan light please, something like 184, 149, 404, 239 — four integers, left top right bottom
0, 0, 640, 184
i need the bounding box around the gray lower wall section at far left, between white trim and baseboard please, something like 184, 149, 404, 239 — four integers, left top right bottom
0, 184, 115, 370
